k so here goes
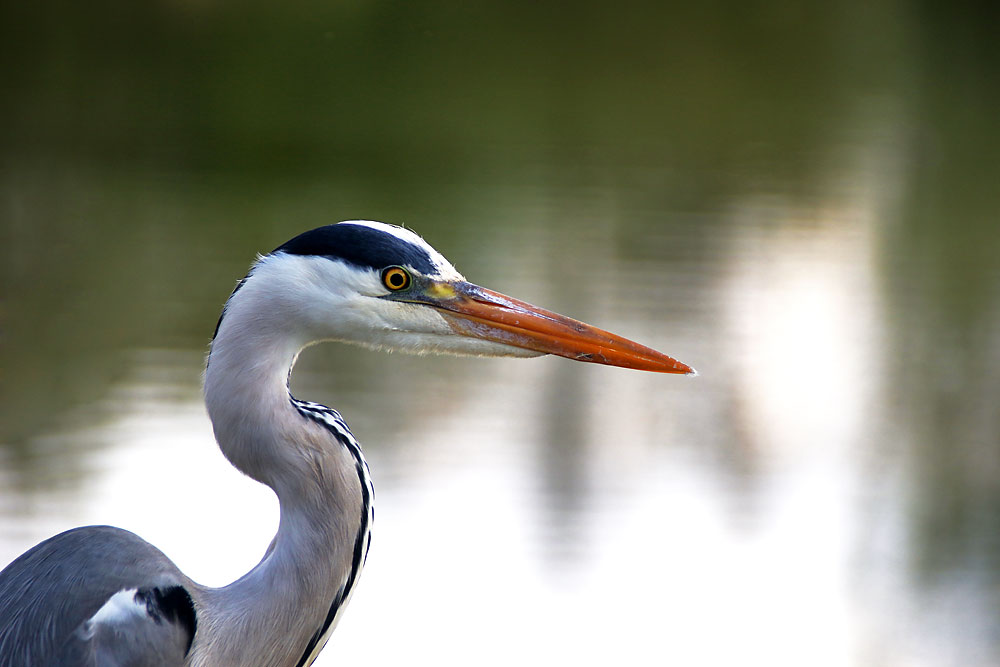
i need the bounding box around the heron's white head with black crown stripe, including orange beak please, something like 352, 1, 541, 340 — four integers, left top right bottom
220, 221, 694, 374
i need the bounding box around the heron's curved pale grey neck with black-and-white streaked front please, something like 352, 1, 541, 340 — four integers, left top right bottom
192, 285, 372, 666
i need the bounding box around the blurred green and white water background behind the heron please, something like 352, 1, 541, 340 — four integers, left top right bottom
0, 0, 1000, 667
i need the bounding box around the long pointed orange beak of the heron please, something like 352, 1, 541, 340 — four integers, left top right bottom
420, 282, 697, 375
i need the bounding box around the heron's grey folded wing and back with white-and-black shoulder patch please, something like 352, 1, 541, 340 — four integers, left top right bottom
0, 526, 196, 667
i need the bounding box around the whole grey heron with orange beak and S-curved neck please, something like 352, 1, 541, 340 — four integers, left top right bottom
0, 221, 694, 667
